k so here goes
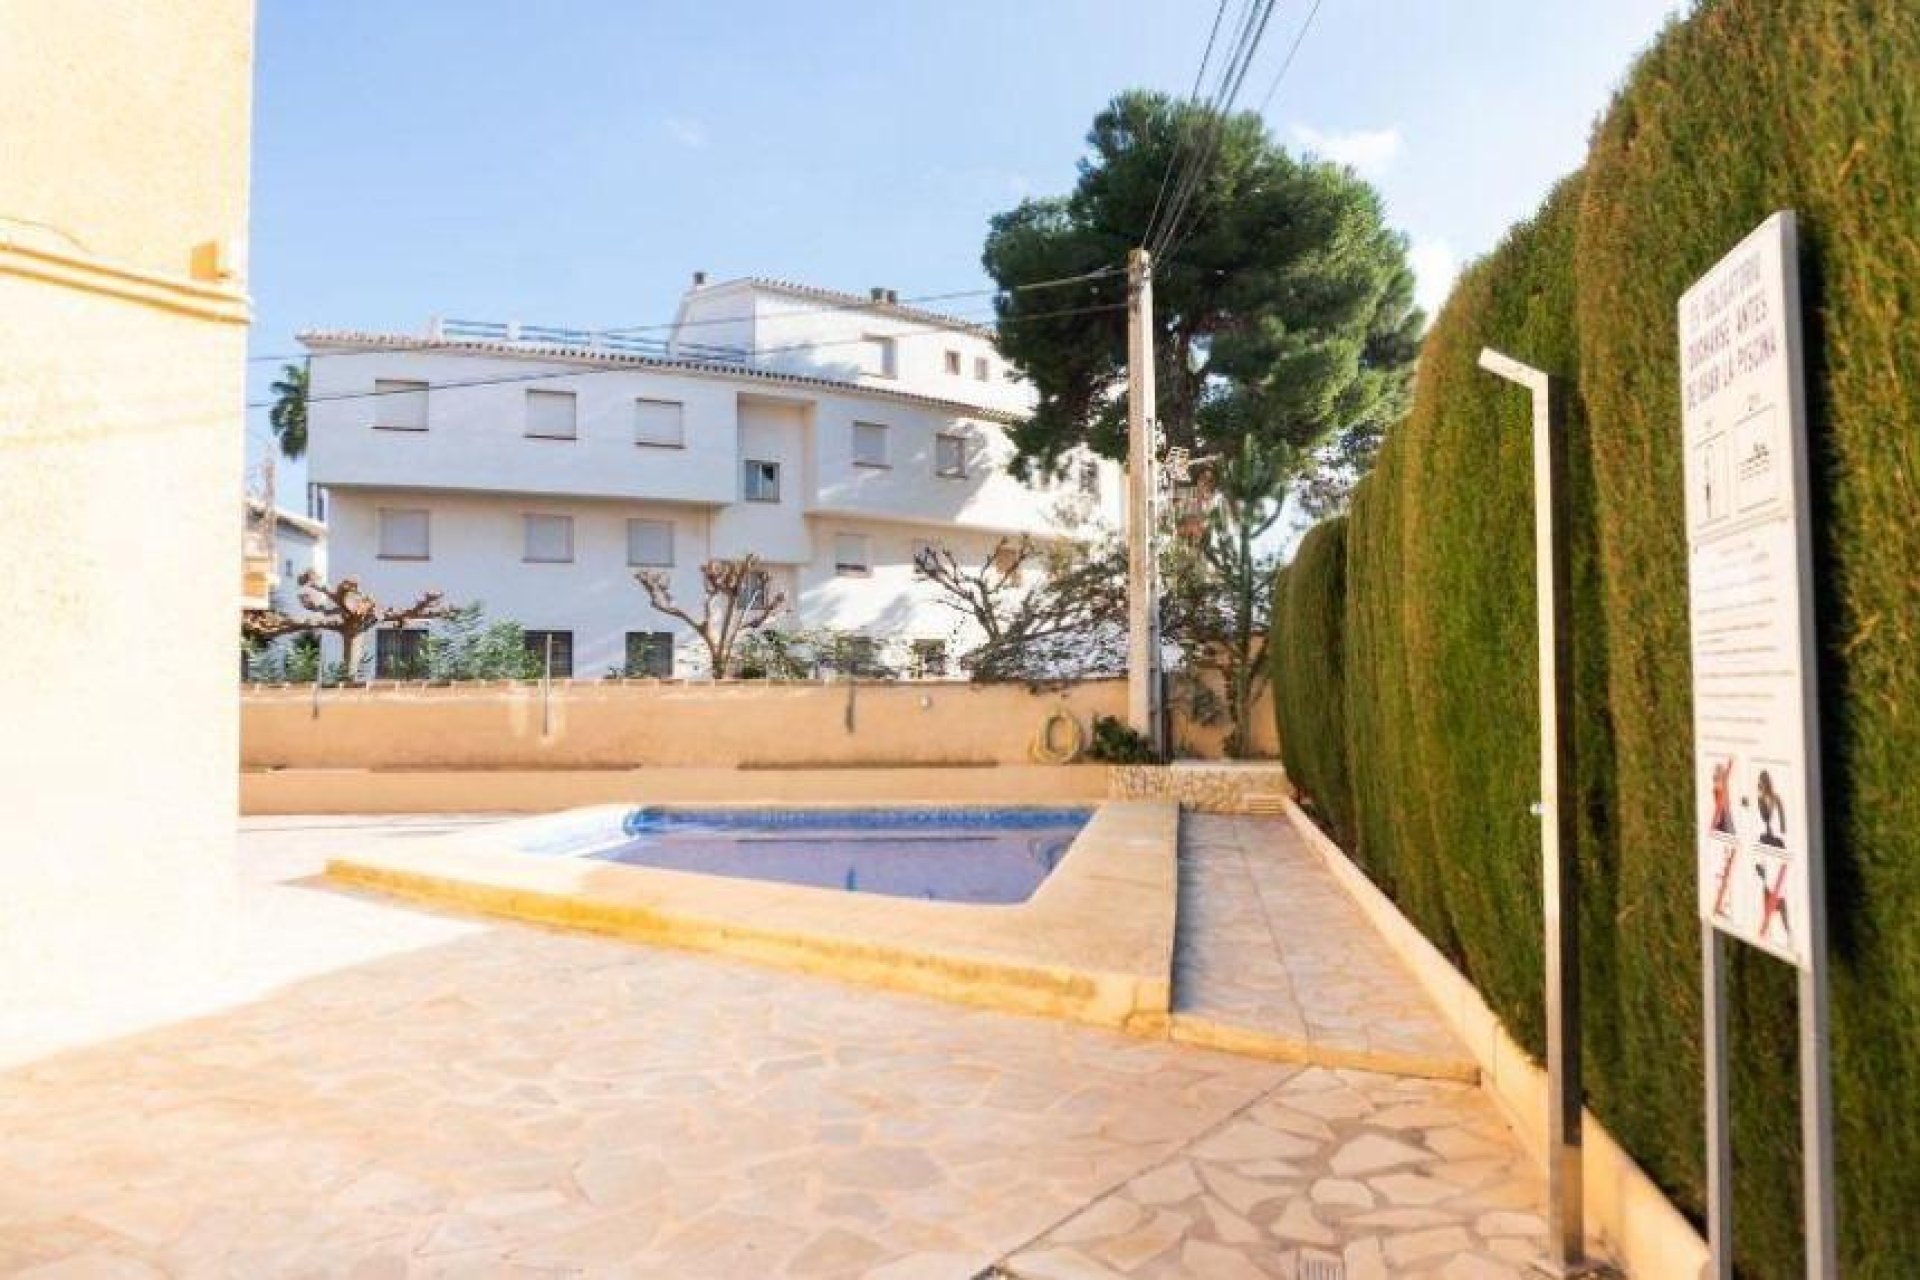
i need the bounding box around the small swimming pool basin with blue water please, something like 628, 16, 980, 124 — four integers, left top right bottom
524, 808, 1092, 902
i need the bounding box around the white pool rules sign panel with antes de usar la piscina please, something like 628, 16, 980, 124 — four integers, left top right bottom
1680, 213, 1820, 967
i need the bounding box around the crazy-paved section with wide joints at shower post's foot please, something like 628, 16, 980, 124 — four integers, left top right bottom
1000, 1067, 1546, 1280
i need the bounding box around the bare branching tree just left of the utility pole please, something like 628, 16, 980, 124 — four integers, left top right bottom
914, 537, 1127, 681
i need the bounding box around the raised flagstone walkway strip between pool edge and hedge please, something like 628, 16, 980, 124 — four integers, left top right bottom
1173, 814, 1476, 1082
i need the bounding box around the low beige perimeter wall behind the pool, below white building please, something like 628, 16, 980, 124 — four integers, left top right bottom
240, 679, 1271, 770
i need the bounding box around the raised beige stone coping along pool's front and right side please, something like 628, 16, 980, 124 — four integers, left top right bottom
326, 800, 1179, 1038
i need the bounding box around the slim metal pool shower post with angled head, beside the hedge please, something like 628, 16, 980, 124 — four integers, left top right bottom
1480, 347, 1603, 1276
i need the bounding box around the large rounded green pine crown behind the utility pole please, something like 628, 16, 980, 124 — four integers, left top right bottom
981, 90, 1421, 479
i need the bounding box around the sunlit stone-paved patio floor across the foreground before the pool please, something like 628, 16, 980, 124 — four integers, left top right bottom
0, 819, 1542, 1280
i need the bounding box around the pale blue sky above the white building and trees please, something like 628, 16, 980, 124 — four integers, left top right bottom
250, 0, 1674, 475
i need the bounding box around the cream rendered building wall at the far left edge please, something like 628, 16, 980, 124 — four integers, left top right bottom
0, 0, 253, 1038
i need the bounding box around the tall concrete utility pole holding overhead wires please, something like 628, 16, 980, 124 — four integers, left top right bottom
1127, 249, 1165, 752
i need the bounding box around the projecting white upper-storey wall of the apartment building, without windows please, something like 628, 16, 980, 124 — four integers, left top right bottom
307, 340, 1121, 537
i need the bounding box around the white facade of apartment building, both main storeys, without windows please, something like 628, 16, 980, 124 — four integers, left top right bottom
309, 326, 1123, 677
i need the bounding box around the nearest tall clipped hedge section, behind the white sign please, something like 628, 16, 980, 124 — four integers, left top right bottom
1578, 0, 1920, 1276
